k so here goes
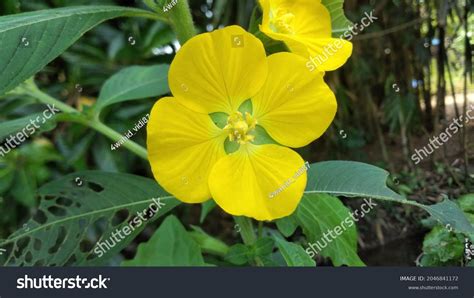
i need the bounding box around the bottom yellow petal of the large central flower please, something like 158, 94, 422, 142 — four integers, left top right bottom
209, 144, 307, 220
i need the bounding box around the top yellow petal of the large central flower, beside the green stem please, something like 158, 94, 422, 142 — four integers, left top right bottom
169, 26, 267, 114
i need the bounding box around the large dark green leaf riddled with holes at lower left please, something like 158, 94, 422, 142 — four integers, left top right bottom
0, 171, 180, 266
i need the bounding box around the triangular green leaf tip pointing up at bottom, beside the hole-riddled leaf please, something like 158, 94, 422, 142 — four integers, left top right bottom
122, 215, 206, 266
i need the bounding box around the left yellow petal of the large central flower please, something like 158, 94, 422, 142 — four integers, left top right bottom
147, 97, 226, 203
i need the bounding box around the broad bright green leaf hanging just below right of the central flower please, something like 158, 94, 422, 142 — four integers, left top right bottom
293, 194, 364, 266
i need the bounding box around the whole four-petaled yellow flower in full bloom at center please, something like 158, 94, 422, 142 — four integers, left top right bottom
148, 26, 337, 220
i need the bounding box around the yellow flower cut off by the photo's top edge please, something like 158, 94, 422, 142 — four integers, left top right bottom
259, 0, 352, 71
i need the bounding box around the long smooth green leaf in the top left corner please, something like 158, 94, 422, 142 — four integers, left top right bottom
0, 5, 155, 95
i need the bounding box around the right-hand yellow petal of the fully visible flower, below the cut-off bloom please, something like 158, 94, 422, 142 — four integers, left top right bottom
252, 53, 337, 147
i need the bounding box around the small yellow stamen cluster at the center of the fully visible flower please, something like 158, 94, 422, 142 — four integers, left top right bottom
224, 112, 257, 145
